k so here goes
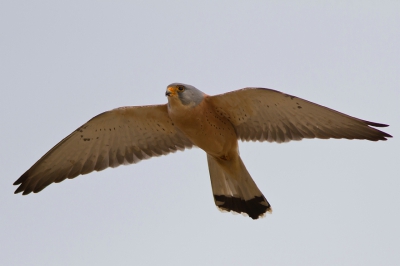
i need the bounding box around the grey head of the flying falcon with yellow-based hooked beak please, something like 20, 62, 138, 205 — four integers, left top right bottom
165, 83, 206, 106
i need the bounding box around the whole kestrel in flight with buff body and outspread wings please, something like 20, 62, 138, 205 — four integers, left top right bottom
14, 83, 392, 219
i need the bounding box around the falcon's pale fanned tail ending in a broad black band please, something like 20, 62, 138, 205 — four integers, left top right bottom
207, 154, 272, 219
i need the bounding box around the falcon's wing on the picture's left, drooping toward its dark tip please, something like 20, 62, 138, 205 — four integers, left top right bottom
14, 104, 193, 195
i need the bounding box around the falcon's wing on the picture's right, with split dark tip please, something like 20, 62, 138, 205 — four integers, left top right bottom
208, 88, 391, 142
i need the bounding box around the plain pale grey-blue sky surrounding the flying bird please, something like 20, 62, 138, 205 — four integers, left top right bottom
0, 0, 400, 266
